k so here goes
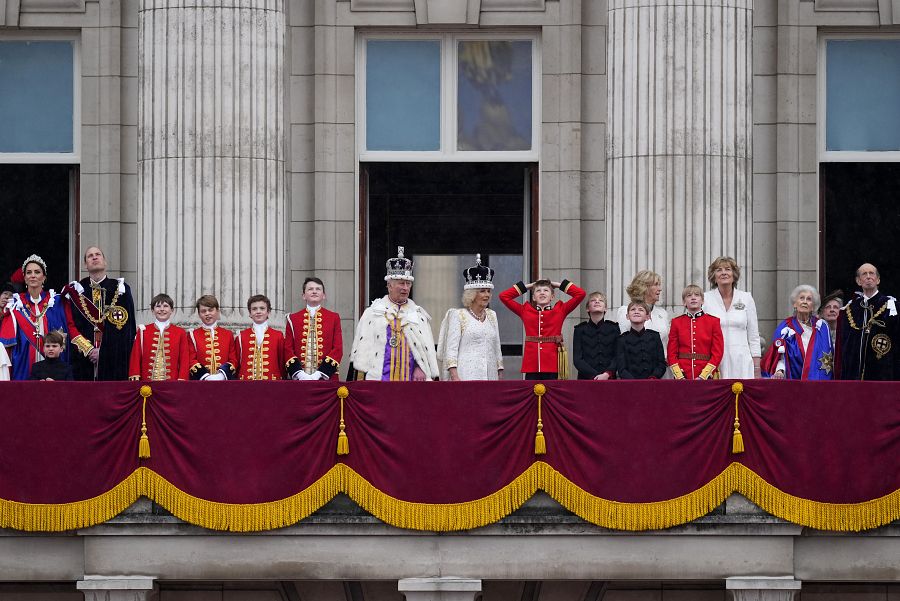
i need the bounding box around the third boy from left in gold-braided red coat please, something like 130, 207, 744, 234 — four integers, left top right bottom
238, 294, 285, 380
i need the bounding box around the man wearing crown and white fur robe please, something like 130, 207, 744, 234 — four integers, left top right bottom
350, 246, 438, 382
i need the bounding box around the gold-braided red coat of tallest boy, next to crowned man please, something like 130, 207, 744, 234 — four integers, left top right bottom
284, 307, 344, 380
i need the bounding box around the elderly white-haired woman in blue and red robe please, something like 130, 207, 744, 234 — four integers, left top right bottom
762, 284, 834, 380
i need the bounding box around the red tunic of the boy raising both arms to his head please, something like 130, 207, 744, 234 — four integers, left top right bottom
500, 280, 585, 373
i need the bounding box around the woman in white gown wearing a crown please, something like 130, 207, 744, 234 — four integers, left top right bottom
438, 255, 503, 380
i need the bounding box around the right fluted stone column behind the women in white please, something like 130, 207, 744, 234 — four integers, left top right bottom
606, 0, 753, 306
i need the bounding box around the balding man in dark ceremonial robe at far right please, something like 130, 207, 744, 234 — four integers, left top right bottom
834, 263, 900, 380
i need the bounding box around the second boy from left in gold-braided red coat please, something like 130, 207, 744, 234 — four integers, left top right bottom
191, 294, 238, 380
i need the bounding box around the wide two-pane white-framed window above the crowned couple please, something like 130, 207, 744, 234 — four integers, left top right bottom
357, 32, 540, 161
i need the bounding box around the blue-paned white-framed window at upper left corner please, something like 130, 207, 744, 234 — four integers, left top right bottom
0, 36, 80, 163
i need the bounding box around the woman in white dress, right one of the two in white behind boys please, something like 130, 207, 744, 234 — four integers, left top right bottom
703, 257, 762, 379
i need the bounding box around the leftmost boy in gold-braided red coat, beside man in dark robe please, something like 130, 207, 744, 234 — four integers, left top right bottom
128, 294, 196, 381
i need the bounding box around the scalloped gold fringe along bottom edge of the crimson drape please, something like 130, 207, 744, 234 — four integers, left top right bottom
0, 461, 900, 532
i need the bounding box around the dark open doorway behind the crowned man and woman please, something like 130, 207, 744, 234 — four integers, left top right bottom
360, 163, 537, 355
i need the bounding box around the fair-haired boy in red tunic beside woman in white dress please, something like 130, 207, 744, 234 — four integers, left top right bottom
666, 284, 725, 380
